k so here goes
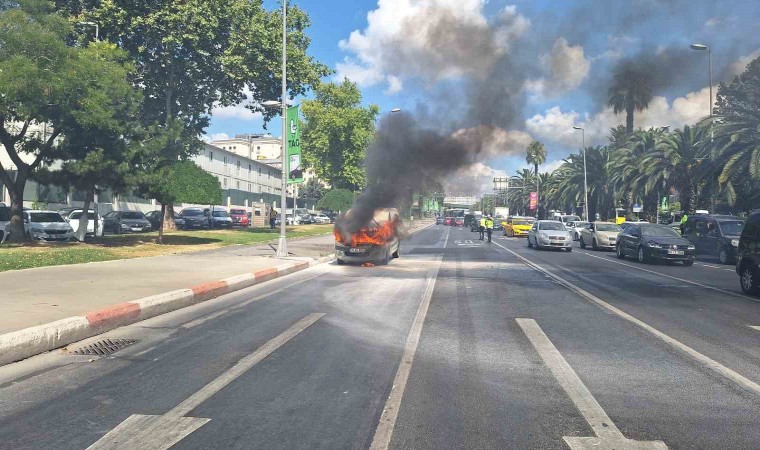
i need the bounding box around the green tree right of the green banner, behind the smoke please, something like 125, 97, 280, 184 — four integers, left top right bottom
301, 79, 380, 190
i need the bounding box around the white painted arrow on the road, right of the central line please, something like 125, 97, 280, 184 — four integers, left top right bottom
515, 319, 668, 449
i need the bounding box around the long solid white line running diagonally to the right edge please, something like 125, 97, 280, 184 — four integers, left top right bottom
496, 243, 760, 395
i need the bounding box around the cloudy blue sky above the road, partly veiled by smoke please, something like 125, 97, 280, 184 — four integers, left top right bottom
203, 0, 760, 192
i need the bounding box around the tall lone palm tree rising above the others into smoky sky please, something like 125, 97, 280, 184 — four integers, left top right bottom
608, 64, 652, 135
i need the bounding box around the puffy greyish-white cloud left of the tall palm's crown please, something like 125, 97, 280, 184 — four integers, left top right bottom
526, 37, 591, 99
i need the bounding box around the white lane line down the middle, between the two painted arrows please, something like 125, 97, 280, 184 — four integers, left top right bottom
370, 257, 442, 450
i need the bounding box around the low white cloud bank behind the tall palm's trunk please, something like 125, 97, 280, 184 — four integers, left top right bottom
525, 88, 710, 148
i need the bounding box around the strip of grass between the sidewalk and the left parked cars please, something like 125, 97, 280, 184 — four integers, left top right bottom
0, 225, 333, 272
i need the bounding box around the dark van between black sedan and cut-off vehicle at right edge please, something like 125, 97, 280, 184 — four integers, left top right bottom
682, 215, 745, 264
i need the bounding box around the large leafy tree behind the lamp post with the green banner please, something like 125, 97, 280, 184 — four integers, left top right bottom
58, 0, 330, 232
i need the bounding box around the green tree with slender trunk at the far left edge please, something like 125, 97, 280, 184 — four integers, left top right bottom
0, 0, 136, 242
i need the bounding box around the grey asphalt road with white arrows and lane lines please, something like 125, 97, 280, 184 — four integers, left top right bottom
0, 226, 760, 450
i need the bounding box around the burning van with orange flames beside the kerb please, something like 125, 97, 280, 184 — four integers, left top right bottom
334, 208, 400, 264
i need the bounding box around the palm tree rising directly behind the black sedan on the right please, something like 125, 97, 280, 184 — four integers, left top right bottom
641, 125, 707, 211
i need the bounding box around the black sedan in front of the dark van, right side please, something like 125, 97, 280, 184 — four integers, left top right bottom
615, 223, 697, 266
